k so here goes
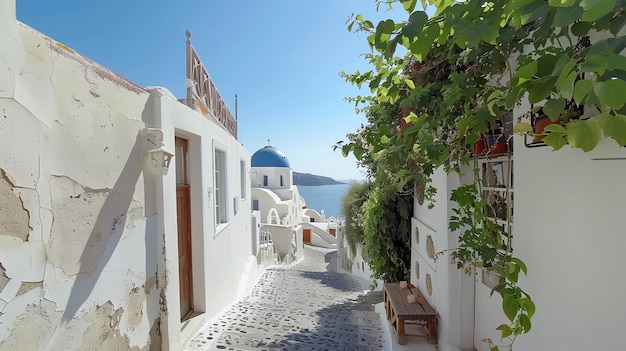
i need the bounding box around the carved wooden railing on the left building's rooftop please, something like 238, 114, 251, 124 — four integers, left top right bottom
186, 31, 237, 138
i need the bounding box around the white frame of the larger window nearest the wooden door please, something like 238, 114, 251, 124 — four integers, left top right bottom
213, 141, 230, 231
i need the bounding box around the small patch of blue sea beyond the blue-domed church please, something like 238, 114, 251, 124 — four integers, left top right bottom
297, 183, 350, 220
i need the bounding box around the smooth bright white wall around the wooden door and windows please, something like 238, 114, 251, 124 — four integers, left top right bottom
152, 89, 258, 349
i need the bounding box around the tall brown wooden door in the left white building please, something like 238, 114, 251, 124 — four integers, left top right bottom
175, 138, 193, 320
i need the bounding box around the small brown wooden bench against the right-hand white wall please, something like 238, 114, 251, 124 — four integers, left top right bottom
383, 283, 437, 345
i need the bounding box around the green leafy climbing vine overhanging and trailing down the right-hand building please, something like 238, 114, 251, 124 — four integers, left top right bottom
336, 0, 626, 350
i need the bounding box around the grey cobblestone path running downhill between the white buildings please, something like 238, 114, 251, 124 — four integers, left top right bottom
184, 247, 384, 351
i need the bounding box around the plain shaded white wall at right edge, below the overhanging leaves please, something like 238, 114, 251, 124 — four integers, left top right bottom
514, 106, 626, 351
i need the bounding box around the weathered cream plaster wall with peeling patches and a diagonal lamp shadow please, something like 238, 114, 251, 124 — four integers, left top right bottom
0, 1, 160, 350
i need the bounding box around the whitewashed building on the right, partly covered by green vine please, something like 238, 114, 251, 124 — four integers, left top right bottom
410, 48, 626, 351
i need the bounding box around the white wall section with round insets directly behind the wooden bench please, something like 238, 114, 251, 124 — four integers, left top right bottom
410, 169, 473, 350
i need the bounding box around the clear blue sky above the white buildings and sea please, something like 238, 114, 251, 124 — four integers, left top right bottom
16, 0, 410, 179
